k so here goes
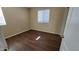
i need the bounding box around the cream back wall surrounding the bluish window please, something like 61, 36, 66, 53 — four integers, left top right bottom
30, 7, 68, 35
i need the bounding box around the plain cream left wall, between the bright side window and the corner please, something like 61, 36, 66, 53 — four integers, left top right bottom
2, 7, 30, 37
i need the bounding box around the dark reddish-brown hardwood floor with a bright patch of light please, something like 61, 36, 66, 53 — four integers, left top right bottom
7, 30, 62, 51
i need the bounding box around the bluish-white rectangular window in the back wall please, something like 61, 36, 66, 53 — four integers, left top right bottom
38, 9, 49, 23
